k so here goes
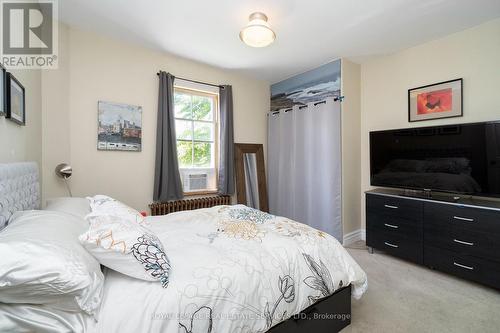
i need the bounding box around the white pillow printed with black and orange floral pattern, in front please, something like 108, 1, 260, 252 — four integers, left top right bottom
79, 214, 170, 288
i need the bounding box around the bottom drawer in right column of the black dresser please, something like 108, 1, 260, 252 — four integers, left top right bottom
424, 244, 500, 289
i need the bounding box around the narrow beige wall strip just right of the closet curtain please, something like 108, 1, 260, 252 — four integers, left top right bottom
341, 59, 361, 236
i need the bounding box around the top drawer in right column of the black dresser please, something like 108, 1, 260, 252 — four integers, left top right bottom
424, 202, 500, 236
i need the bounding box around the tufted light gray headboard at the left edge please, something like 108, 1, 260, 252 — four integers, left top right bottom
0, 162, 40, 230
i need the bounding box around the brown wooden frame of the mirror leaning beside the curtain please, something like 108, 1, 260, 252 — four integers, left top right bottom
234, 143, 269, 212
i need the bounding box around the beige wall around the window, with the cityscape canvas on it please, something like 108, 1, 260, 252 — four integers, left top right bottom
42, 26, 270, 210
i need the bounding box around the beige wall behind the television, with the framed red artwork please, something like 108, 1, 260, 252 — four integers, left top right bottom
360, 19, 500, 228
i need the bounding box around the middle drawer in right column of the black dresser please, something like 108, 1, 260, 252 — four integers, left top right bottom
424, 225, 500, 262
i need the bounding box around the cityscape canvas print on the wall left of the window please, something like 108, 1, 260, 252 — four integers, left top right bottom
97, 101, 142, 151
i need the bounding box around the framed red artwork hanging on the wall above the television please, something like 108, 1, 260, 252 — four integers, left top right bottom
408, 78, 463, 122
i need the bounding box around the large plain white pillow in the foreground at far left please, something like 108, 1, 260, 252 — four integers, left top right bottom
0, 211, 104, 315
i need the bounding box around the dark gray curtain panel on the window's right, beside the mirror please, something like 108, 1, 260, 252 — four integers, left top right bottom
218, 85, 234, 195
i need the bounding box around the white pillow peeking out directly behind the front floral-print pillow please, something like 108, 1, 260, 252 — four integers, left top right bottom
87, 194, 144, 224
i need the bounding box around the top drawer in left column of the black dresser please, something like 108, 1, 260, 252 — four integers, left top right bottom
366, 193, 423, 222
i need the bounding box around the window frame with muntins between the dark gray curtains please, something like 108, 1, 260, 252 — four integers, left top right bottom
174, 85, 220, 196
